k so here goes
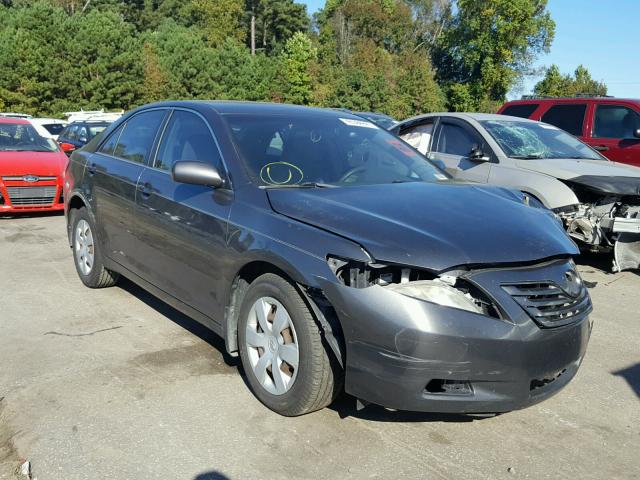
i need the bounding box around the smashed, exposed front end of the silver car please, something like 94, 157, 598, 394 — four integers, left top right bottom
554, 176, 640, 272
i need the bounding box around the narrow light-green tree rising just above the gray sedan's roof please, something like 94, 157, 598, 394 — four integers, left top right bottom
282, 32, 317, 105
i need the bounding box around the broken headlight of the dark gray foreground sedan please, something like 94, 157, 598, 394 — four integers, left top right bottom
327, 256, 501, 318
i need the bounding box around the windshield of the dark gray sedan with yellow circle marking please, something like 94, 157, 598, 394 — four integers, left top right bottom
225, 114, 449, 187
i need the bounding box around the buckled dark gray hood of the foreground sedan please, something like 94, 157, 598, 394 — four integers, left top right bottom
267, 182, 578, 271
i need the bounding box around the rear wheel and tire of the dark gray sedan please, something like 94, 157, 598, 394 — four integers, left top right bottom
70, 207, 120, 288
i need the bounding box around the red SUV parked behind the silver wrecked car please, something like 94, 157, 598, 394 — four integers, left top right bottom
498, 96, 640, 167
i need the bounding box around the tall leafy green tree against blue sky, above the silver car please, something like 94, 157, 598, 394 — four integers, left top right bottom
434, 0, 555, 110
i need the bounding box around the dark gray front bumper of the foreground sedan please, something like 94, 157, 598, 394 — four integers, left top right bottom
323, 258, 591, 413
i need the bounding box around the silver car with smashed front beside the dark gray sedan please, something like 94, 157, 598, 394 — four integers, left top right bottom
393, 113, 640, 270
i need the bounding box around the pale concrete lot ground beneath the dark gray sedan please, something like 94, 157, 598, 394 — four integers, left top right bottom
0, 215, 640, 480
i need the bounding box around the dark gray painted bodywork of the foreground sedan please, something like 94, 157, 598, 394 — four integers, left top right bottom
65, 102, 590, 411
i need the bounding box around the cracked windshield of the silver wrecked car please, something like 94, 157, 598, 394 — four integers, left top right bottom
480, 120, 605, 160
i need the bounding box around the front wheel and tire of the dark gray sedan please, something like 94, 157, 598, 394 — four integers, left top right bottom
238, 273, 343, 417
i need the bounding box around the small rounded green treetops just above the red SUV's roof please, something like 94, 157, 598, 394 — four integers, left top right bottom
533, 65, 607, 97
